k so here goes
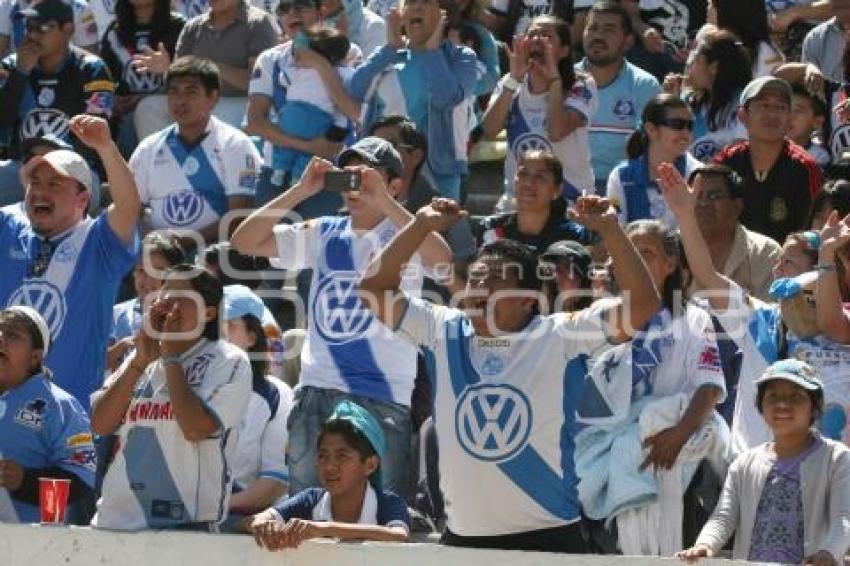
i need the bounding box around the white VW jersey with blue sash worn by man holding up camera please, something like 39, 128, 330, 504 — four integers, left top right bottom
274, 216, 423, 407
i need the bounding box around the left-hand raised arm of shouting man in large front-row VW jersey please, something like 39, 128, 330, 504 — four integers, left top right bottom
358, 199, 466, 328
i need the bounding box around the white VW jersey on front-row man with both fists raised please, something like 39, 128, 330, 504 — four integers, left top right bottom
397, 298, 608, 536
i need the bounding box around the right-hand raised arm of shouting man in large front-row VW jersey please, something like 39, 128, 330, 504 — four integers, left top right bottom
568, 196, 661, 342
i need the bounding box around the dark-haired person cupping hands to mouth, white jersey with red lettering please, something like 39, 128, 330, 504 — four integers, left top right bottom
92, 264, 251, 532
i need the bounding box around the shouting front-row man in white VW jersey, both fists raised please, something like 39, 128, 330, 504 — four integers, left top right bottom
359, 197, 659, 553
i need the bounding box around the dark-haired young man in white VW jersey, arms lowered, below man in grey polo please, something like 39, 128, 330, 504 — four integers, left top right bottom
130, 57, 262, 250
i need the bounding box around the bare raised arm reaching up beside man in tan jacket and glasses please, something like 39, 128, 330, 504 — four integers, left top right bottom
658, 163, 730, 312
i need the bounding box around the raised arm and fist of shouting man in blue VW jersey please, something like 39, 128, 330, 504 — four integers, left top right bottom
70, 114, 142, 244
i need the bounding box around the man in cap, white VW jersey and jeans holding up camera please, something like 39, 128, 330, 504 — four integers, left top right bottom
231, 137, 452, 500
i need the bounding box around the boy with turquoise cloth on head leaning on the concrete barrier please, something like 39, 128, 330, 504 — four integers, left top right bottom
240, 401, 410, 550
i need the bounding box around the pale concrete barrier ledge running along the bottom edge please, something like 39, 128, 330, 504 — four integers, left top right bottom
0, 525, 756, 566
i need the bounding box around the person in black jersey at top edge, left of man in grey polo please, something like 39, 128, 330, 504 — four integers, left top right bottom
100, 0, 186, 156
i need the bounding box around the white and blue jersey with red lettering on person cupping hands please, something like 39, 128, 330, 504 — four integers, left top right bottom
92, 339, 251, 531
